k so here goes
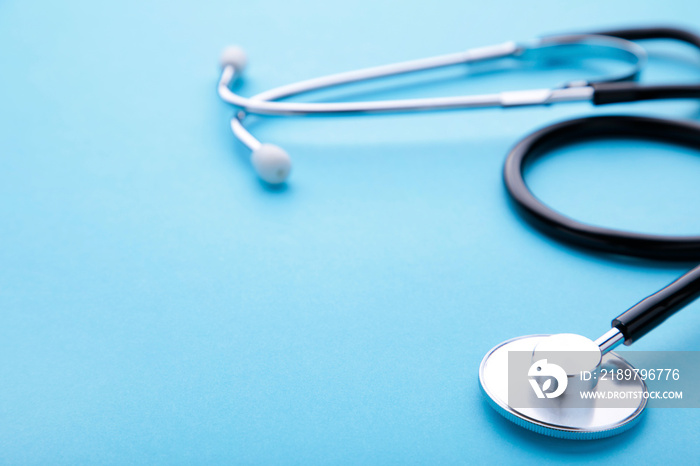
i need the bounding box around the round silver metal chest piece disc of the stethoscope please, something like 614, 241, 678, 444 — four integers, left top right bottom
479, 335, 647, 440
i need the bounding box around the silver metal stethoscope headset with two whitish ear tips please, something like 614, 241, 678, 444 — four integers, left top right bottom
218, 34, 646, 184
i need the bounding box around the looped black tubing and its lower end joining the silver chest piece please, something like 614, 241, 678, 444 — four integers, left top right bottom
503, 116, 700, 344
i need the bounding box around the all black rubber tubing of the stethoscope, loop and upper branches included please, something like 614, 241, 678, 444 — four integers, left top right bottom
503, 27, 700, 345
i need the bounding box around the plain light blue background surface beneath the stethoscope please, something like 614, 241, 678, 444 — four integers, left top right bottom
0, 0, 700, 464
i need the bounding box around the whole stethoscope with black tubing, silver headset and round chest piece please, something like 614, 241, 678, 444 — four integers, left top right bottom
218, 28, 700, 439
